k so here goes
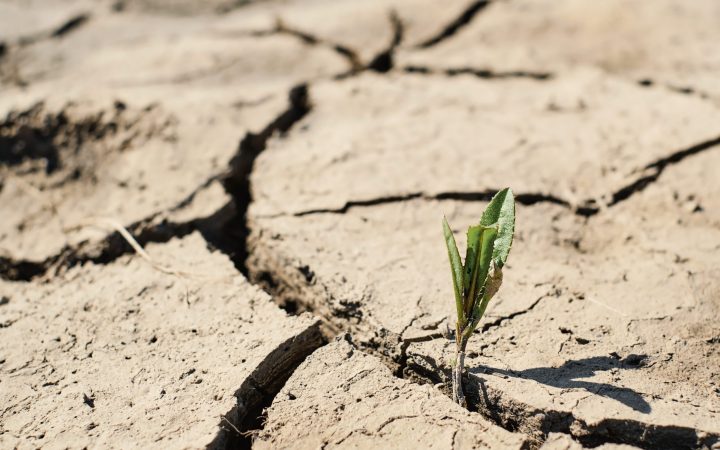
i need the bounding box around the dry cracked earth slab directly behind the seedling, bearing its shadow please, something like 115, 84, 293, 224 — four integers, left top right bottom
249, 191, 720, 447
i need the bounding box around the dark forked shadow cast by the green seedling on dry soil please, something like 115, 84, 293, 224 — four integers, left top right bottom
469, 355, 651, 414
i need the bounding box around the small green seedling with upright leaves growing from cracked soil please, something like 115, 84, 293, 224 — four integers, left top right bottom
443, 188, 515, 407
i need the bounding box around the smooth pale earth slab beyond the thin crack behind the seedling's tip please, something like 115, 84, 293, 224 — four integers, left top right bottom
252, 70, 720, 217
